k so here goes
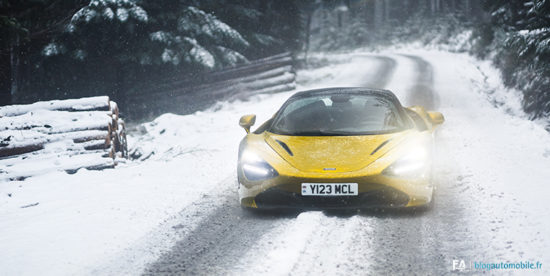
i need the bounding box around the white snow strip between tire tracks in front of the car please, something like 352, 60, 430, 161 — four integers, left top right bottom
234, 212, 374, 275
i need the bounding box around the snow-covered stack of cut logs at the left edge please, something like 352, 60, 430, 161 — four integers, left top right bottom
0, 96, 128, 181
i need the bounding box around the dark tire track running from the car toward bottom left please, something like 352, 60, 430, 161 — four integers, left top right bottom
144, 194, 297, 275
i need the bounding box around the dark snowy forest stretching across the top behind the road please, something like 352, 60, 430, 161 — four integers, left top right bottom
0, 0, 550, 121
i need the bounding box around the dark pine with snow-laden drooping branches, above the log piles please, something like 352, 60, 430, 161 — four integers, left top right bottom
43, 0, 252, 99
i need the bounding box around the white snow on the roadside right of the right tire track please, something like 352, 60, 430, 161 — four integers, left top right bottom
414, 48, 550, 263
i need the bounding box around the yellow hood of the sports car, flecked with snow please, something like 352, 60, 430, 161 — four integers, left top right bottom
264, 131, 408, 172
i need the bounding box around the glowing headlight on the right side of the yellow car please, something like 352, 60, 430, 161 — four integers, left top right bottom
382, 147, 430, 178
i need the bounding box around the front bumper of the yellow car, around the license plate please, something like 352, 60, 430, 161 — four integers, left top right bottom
239, 172, 433, 209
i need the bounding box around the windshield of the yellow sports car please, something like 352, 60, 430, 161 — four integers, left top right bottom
270, 94, 407, 136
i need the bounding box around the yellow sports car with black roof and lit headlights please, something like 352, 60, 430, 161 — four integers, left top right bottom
237, 88, 444, 209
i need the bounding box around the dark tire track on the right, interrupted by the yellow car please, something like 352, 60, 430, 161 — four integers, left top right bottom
365, 55, 496, 275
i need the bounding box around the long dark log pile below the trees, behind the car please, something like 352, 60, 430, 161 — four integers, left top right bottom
124, 53, 296, 120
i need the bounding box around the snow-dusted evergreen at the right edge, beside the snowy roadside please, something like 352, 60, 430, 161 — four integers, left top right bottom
485, 0, 550, 118
